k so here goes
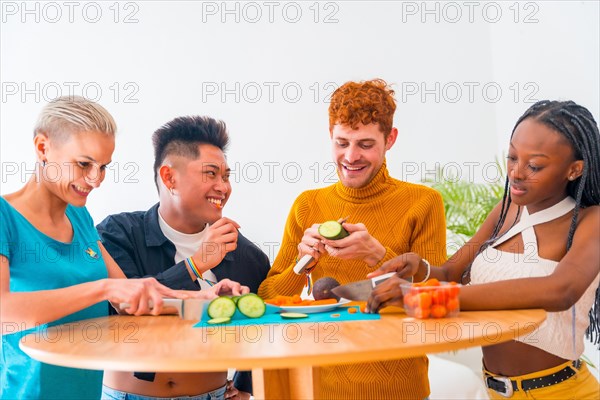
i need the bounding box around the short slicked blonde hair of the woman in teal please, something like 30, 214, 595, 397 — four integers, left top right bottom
33, 96, 117, 142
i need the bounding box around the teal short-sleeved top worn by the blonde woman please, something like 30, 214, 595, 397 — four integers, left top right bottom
0, 197, 109, 399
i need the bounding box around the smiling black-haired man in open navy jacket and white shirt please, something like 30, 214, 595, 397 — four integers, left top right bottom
97, 116, 269, 399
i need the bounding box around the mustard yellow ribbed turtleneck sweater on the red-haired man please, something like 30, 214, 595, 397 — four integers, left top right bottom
258, 164, 446, 399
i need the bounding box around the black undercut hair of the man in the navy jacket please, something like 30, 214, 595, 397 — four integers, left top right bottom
152, 116, 229, 189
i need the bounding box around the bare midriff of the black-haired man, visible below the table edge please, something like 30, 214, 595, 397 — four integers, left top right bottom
103, 371, 227, 397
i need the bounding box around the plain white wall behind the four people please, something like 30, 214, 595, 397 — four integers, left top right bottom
0, 1, 600, 384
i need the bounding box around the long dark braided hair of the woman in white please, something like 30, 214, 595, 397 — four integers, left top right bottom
462, 100, 600, 345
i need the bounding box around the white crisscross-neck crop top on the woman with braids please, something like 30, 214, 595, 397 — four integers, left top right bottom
471, 197, 600, 360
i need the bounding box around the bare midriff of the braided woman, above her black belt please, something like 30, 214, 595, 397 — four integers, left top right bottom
482, 340, 567, 376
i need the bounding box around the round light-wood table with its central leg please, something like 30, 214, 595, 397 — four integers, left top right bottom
21, 310, 546, 399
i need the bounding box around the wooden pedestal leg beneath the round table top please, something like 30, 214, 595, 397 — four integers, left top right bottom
252, 367, 314, 400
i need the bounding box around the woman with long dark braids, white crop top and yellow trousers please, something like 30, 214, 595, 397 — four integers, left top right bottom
368, 101, 600, 399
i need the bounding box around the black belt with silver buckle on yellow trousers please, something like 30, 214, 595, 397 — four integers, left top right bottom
485, 360, 581, 397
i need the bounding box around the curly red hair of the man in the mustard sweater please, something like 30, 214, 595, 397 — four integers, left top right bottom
329, 79, 396, 139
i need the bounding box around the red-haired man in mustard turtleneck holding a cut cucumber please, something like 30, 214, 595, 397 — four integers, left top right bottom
259, 79, 446, 399
